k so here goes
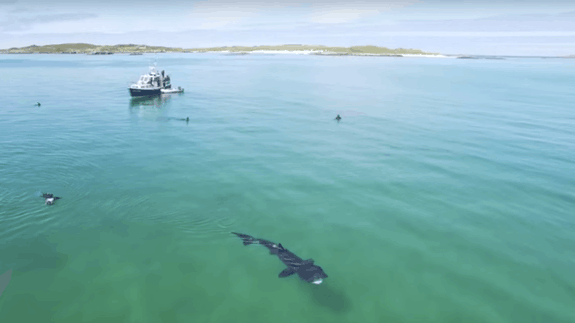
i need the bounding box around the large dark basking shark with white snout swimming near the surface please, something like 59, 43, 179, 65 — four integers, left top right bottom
232, 232, 327, 285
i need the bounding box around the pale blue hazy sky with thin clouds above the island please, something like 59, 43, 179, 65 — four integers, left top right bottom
0, 0, 575, 56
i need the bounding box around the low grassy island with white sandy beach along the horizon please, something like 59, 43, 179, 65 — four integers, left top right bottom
0, 43, 440, 56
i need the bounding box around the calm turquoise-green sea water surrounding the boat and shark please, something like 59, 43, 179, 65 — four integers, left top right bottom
0, 54, 575, 323
